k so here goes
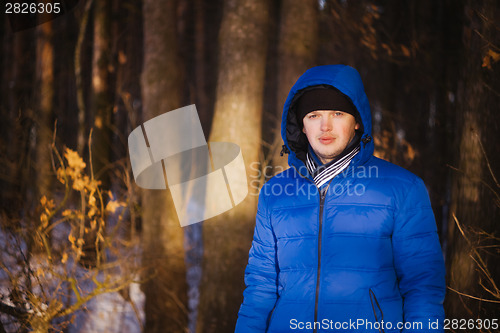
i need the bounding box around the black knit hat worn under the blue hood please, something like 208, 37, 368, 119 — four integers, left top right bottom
294, 87, 361, 128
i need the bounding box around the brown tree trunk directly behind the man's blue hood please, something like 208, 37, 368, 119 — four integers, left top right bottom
272, 0, 319, 172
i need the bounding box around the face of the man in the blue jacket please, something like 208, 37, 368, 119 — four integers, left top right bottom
302, 110, 359, 163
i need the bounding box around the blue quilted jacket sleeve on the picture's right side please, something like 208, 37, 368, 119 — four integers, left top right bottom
392, 178, 446, 333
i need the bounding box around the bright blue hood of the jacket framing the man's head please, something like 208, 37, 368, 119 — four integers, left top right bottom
281, 65, 374, 176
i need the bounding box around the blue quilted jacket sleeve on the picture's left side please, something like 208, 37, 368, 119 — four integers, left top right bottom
235, 187, 278, 333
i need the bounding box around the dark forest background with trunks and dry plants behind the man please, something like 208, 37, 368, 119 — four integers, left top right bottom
0, 0, 500, 333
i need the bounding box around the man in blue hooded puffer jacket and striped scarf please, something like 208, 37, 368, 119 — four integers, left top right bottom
236, 65, 445, 333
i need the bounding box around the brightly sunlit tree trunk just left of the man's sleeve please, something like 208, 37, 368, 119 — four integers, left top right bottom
197, 0, 270, 333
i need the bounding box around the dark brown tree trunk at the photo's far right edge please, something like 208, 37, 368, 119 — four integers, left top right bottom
446, 0, 500, 322
